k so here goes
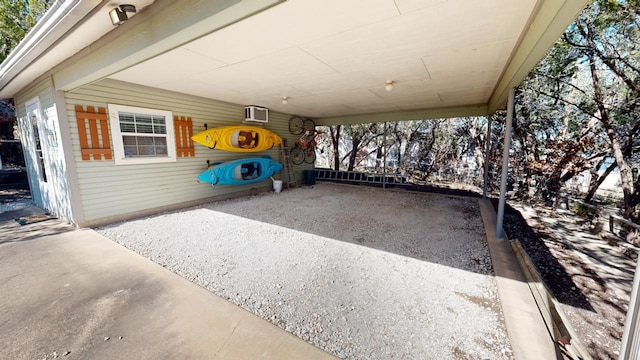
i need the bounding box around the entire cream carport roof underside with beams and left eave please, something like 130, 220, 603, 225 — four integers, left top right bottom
0, 0, 588, 124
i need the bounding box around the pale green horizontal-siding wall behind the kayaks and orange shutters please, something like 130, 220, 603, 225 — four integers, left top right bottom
65, 80, 312, 226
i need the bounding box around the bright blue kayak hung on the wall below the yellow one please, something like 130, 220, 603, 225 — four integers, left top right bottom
198, 157, 282, 185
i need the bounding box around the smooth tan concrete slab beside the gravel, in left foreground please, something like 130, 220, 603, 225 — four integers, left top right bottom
0, 208, 333, 359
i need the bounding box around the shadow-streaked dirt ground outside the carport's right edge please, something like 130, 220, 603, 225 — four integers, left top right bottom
504, 204, 636, 359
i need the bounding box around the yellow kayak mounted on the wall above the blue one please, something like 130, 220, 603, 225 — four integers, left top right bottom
191, 125, 282, 152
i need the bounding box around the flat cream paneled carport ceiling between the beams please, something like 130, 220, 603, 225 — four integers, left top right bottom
110, 0, 585, 118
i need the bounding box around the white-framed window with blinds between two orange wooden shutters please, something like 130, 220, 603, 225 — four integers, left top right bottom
109, 104, 176, 165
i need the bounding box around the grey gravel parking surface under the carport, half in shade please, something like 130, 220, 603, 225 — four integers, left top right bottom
97, 183, 513, 359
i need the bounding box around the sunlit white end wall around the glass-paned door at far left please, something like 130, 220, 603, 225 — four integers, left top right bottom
14, 77, 73, 219
